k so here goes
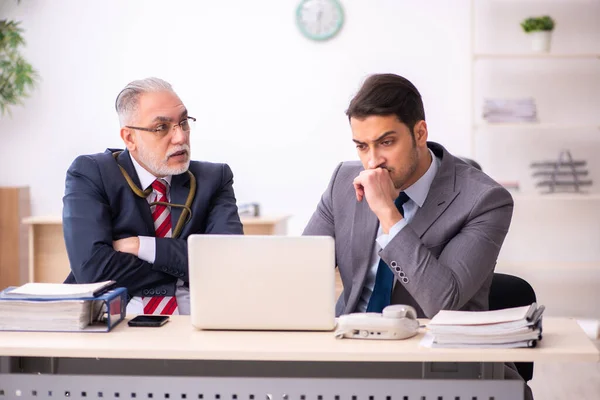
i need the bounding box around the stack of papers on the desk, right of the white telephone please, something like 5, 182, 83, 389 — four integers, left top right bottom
422, 303, 544, 348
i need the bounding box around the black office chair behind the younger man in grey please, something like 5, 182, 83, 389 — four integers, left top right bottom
461, 157, 536, 382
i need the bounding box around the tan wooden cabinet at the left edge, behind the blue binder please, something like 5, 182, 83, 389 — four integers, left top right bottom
0, 187, 30, 289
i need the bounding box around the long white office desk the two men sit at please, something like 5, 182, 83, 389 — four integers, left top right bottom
0, 316, 599, 400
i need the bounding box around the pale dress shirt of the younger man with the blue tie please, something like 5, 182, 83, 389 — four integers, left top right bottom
356, 150, 442, 312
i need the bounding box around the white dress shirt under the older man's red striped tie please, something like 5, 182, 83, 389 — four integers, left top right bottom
127, 155, 190, 315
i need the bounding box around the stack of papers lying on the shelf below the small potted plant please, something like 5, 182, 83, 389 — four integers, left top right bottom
483, 98, 537, 123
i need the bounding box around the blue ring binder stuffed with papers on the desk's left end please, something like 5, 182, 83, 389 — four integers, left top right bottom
0, 281, 127, 332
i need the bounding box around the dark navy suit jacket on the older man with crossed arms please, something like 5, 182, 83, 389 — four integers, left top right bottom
63, 149, 243, 296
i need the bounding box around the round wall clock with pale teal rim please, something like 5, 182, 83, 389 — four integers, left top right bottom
296, 0, 344, 40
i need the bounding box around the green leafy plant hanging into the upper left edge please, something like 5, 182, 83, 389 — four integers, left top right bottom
0, 19, 38, 115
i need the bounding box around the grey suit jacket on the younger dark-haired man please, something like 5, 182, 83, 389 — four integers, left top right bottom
304, 142, 513, 318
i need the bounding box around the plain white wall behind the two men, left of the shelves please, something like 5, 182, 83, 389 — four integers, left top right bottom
0, 0, 470, 234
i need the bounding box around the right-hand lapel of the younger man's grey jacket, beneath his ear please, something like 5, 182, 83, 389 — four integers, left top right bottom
410, 143, 460, 237
